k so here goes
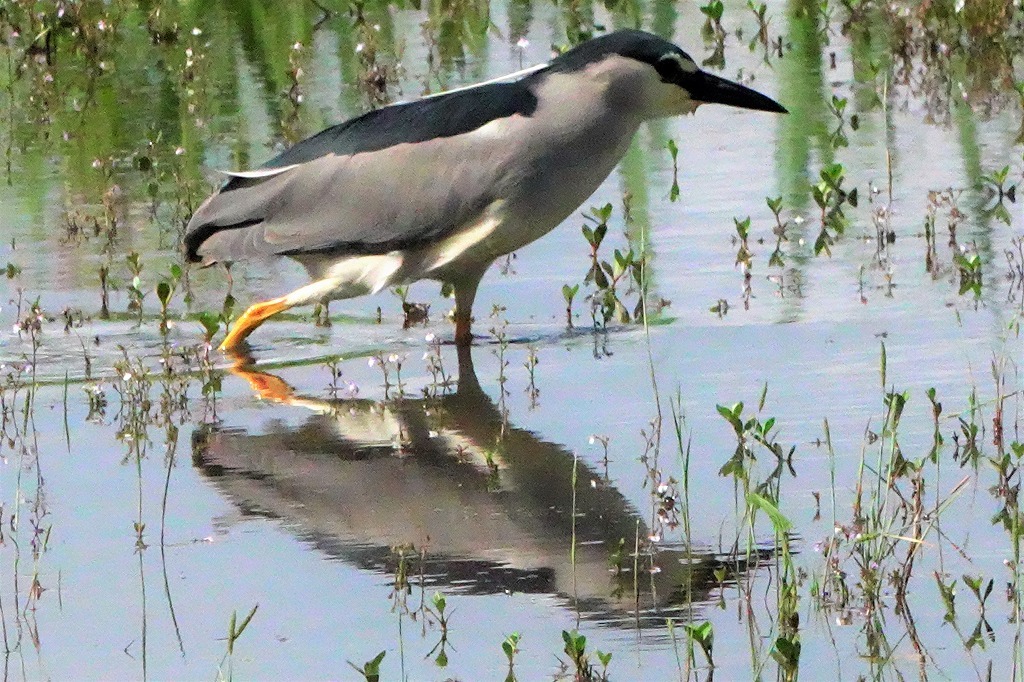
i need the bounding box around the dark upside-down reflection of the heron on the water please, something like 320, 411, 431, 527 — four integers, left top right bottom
193, 348, 767, 626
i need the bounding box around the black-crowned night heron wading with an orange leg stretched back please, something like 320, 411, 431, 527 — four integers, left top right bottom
184, 31, 785, 350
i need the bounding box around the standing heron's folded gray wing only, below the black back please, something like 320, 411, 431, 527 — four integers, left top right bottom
186, 131, 504, 262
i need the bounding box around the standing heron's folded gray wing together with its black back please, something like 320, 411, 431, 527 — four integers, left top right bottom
184, 78, 537, 262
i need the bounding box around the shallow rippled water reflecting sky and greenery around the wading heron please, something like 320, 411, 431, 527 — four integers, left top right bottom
0, 1, 1024, 680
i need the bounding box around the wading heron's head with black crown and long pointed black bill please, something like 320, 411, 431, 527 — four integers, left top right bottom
551, 31, 786, 119
